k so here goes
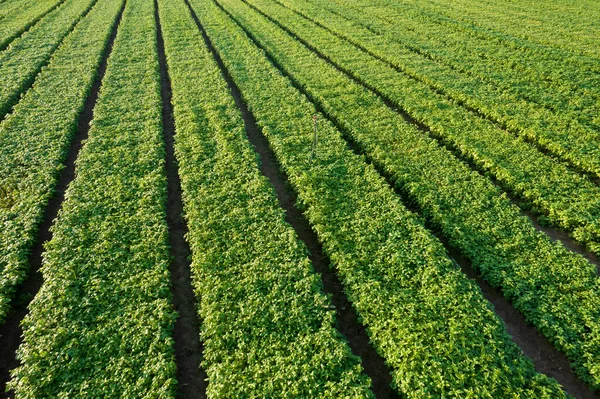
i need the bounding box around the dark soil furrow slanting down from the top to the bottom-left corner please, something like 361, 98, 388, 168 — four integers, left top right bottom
0, 3, 125, 397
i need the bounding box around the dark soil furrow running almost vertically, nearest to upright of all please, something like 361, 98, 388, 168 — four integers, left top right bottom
154, 0, 207, 399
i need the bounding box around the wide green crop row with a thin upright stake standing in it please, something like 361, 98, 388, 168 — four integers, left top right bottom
192, 0, 572, 397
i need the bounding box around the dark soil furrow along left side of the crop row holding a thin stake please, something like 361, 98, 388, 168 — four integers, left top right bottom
186, 0, 399, 399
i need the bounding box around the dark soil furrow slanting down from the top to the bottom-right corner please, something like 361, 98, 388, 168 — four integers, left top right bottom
216, 3, 598, 399
